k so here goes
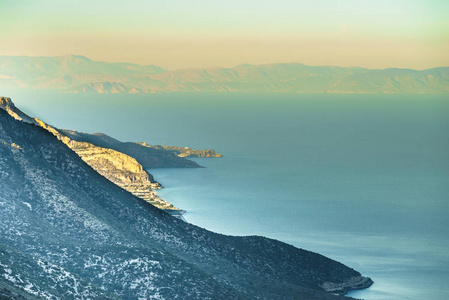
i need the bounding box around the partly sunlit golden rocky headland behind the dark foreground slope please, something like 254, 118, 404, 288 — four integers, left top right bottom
0, 97, 222, 213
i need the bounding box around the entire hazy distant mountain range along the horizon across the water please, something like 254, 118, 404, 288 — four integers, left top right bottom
0, 55, 449, 93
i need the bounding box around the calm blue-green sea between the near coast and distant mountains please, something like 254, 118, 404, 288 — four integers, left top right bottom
9, 91, 449, 300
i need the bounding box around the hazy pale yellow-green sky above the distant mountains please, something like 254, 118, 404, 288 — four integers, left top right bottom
0, 0, 449, 69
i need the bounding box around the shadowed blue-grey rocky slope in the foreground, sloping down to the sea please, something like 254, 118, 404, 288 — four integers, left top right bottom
0, 100, 372, 299
